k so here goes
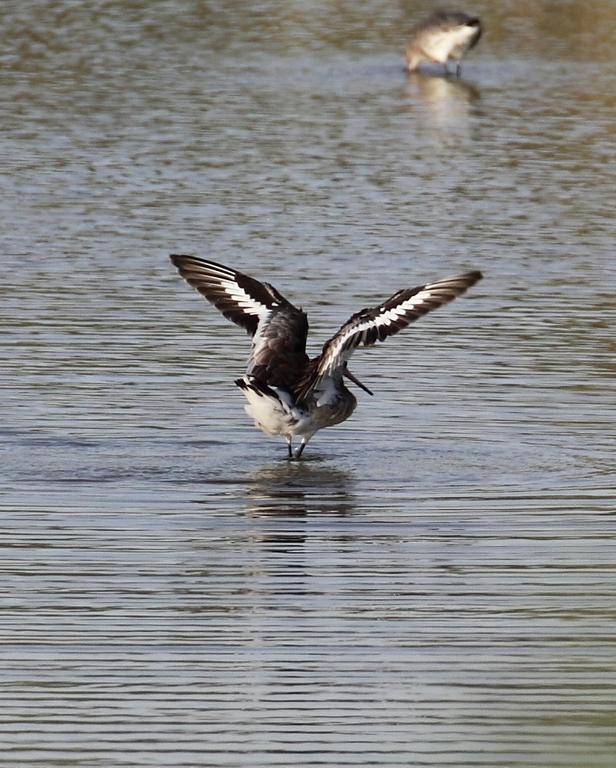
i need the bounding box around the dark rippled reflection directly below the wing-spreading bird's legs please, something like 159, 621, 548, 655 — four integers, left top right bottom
247, 462, 354, 517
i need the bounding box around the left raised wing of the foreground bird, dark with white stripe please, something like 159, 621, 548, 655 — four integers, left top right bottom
170, 254, 308, 386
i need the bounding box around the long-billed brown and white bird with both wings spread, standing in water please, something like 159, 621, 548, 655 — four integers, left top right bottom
171, 256, 481, 459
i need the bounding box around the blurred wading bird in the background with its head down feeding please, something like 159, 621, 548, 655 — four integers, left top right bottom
405, 11, 481, 77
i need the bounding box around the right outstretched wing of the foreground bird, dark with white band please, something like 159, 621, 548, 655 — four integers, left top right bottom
298, 271, 482, 400
